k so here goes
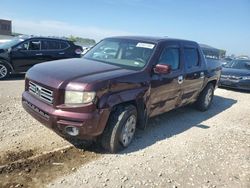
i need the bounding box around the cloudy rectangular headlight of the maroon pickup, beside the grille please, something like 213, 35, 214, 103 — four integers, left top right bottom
64, 91, 96, 104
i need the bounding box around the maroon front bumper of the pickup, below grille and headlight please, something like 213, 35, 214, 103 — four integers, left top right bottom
22, 91, 110, 140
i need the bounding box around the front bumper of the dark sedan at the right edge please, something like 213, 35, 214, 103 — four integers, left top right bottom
219, 78, 250, 91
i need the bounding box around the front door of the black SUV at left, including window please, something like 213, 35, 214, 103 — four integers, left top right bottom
11, 39, 45, 72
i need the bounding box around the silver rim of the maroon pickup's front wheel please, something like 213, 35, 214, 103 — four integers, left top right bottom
120, 115, 136, 147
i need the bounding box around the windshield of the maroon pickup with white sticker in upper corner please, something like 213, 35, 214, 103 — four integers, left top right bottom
84, 39, 155, 70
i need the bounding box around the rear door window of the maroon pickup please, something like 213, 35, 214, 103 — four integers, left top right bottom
184, 48, 199, 69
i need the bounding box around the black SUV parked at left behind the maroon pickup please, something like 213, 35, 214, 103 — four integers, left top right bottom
0, 36, 83, 80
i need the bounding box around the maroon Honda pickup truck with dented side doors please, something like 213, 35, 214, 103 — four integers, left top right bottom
22, 37, 221, 152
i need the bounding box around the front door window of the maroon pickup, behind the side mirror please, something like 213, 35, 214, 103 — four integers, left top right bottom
158, 47, 180, 70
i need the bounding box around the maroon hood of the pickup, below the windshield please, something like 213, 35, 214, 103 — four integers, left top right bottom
26, 58, 134, 88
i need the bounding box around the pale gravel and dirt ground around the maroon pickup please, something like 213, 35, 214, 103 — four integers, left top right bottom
0, 76, 250, 188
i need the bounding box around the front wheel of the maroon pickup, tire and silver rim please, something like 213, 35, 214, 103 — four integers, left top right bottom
101, 105, 137, 153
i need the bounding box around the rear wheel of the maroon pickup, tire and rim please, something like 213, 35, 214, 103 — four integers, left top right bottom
196, 83, 214, 112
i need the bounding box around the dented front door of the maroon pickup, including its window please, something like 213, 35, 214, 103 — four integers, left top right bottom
150, 42, 183, 116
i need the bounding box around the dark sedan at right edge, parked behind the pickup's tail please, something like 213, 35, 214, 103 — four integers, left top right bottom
219, 59, 250, 91
